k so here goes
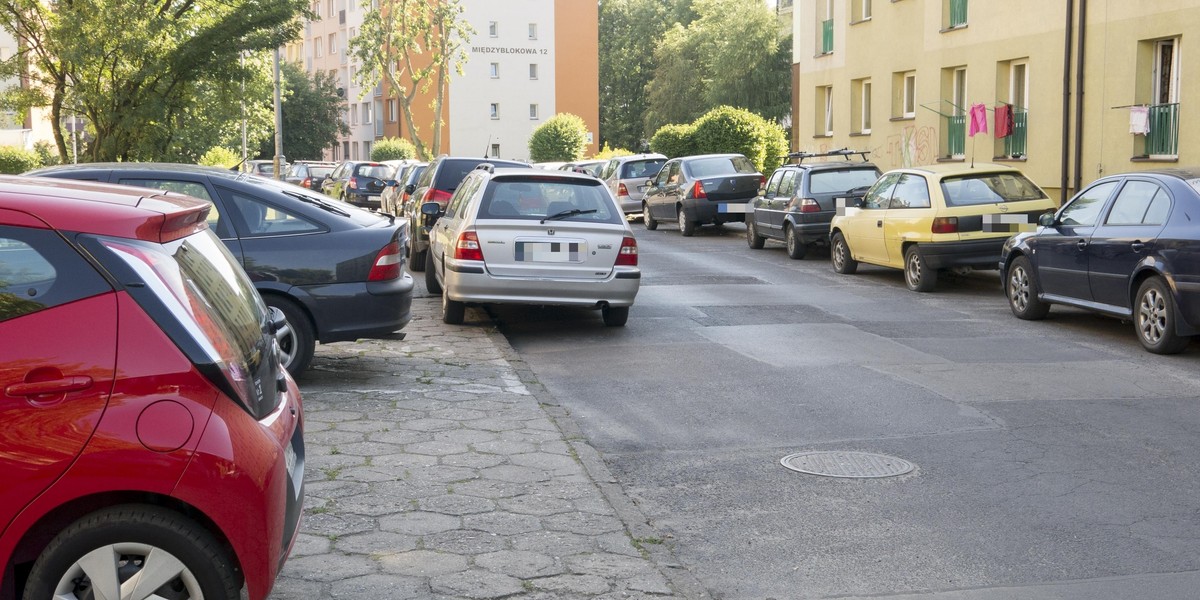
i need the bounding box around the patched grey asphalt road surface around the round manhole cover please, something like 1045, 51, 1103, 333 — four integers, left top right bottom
482, 222, 1200, 599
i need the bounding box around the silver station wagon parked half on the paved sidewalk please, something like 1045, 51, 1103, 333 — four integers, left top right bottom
421, 163, 642, 326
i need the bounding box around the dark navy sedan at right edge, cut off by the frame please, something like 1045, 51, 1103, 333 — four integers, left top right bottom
1000, 169, 1200, 354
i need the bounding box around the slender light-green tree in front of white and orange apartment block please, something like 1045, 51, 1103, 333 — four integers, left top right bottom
349, 0, 475, 160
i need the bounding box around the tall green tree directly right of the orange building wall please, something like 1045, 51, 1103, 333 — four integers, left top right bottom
600, 0, 695, 148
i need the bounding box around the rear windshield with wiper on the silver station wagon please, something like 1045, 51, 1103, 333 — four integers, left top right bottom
479, 175, 625, 223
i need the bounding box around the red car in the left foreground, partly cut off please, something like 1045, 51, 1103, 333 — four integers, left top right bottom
0, 178, 304, 600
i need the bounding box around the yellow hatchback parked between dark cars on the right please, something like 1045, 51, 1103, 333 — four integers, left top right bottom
829, 163, 1056, 292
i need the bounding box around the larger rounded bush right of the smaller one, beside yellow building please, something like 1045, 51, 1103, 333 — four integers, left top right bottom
692, 107, 787, 174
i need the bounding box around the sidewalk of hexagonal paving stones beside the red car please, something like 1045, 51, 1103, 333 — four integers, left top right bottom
271, 298, 707, 600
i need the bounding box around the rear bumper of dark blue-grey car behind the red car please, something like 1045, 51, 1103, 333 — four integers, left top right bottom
304, 272, 415, 343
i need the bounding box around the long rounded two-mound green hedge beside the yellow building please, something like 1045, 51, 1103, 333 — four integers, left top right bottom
650, 107, 787, 174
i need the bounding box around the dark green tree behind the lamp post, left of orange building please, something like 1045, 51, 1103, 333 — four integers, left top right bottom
258, 62, 350, 161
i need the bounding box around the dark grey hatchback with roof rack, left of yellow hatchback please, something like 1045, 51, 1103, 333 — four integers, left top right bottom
746, 149, 880, 258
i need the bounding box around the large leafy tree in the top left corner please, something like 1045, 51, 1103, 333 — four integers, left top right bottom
0, 0, 308, 161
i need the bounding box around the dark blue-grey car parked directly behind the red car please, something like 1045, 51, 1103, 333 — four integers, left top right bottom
28, 163, 413, 376
